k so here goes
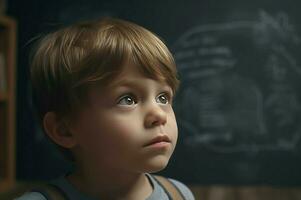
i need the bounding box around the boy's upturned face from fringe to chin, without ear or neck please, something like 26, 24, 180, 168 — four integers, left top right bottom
69, 66, 178, 172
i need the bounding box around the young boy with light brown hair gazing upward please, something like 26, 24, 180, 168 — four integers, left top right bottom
18, 18, 194, 200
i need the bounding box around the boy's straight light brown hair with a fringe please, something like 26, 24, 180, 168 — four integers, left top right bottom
31, 18, 179, 161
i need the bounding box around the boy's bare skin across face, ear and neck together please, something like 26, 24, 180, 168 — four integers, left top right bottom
44, 65, 178, 199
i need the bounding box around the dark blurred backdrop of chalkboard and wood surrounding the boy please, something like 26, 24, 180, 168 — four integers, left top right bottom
0, 0, 301, 199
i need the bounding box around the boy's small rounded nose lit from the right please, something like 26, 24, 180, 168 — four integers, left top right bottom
145, 103, 167, 128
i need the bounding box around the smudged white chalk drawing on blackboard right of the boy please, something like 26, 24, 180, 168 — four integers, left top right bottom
172, 10, 301, 153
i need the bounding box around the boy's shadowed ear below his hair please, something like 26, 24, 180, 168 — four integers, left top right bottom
43, 112, 77, 148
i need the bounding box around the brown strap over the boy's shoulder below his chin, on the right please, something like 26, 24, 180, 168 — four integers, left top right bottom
152, 175, 185, 200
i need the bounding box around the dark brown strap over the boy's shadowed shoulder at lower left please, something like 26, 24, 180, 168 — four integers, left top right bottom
29, 183, 69, 200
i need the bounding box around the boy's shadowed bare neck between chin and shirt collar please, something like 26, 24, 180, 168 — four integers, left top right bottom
67, 164, 153, 200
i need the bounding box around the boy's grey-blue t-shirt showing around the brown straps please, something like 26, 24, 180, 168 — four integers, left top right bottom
15, 173, 195, 200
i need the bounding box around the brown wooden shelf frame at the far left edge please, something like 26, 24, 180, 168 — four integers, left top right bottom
0, 15, 17, 191
